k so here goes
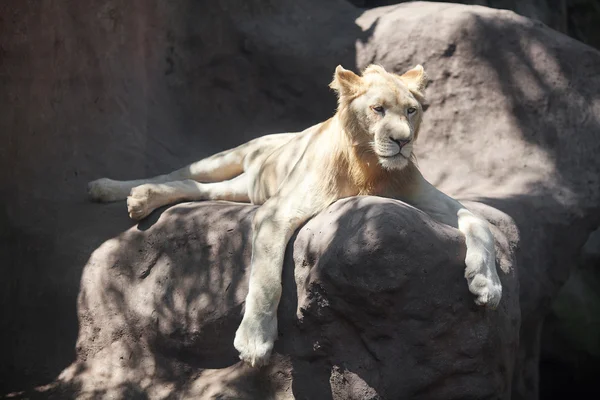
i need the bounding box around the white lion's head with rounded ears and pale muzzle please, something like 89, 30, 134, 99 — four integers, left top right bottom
330, 65, 427, 169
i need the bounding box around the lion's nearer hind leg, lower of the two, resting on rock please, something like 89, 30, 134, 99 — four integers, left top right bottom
127, 174, 250, 220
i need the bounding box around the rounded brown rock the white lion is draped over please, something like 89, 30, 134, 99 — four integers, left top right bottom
61, 197, 520, 400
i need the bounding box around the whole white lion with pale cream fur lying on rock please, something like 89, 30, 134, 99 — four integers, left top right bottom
89, 65, 502, 366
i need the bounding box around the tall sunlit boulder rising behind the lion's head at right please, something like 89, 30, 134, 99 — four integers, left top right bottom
357, 3, 600, 399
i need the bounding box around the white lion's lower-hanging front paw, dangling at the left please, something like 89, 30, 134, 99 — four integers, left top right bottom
233, 312, 277, 367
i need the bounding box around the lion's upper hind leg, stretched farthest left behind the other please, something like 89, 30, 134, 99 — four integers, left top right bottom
88, 133, 295, 202
